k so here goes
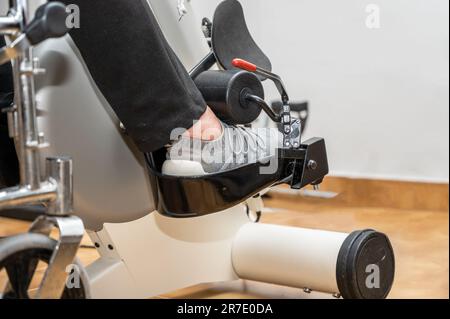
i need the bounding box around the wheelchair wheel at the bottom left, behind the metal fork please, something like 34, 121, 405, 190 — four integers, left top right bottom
0, 233, 90, 299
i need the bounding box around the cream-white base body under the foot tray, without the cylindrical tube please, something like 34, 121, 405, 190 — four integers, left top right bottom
87, 205, 249, 298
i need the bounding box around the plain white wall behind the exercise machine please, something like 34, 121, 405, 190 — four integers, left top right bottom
188, 0, 449, 182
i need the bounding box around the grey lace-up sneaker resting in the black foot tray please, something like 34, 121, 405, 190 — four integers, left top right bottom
167, 123, 283, 174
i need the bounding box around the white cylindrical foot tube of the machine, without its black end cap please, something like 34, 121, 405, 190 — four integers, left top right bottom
232, 224, 348, 293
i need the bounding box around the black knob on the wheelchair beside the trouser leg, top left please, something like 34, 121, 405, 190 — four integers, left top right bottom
25, 2, 69, 45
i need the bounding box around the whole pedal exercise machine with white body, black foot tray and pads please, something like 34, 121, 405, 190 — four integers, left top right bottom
0, 0, 394, 298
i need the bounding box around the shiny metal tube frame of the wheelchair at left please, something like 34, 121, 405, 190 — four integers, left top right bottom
0, 0, 84, 299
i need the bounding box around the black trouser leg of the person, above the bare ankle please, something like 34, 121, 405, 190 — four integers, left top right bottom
54, 0, 206, 152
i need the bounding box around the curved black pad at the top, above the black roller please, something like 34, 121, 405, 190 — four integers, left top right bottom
212, 0, 272, 71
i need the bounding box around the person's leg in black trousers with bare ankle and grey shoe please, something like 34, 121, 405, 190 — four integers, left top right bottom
64, 0, 279, 173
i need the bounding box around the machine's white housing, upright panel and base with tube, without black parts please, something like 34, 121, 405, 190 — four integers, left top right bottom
29, 0, 394, 298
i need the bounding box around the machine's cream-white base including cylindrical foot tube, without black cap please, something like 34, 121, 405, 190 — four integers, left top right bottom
88, 205, 348, 298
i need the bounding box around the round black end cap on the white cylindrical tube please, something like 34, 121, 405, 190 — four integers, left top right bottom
336, 230, 395, 299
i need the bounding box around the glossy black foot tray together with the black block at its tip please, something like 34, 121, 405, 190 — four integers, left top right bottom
146, 138, 328, 218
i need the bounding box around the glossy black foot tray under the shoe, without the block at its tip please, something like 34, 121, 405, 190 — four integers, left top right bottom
146, 150, 285, 218
